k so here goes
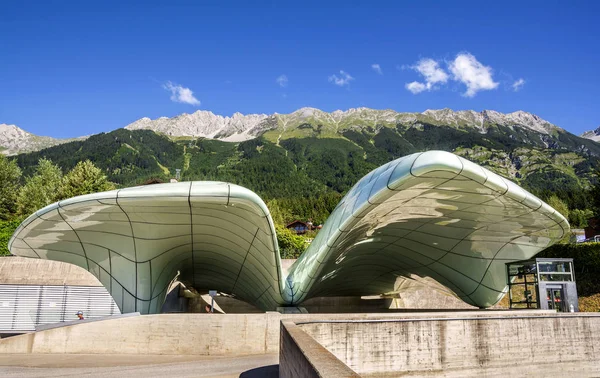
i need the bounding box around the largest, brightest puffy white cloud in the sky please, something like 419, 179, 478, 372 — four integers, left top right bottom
448, 53, 498, 97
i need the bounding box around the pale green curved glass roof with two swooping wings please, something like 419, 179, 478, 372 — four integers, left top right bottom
9, 151, 569, 313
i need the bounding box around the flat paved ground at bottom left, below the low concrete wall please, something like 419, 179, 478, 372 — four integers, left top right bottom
0, 354, 279, 378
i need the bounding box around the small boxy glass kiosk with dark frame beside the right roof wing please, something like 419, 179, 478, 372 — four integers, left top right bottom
506, 258, 579, 312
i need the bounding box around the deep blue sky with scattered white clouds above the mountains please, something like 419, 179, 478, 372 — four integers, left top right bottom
0, 1, 600, 137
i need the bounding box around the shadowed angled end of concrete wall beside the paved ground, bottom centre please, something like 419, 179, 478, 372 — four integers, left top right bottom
279, 320, 360, 378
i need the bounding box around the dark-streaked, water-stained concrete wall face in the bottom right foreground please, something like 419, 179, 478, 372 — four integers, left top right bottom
297, 314, 600, 377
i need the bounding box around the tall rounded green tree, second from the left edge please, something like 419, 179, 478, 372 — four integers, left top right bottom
17, 158, 63, 215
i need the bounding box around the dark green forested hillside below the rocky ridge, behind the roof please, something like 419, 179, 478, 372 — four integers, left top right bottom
15, 123, 600, 215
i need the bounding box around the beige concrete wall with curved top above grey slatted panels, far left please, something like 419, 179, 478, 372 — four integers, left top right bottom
0, 256, 102, 286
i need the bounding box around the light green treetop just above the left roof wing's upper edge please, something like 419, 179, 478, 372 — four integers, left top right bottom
59, 160, 115, 199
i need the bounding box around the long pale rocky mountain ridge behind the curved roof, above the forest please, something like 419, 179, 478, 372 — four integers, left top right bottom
125, 107, 562, 142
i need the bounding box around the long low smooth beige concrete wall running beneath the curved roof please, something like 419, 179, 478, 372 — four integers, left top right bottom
0, 310, 556, 355
